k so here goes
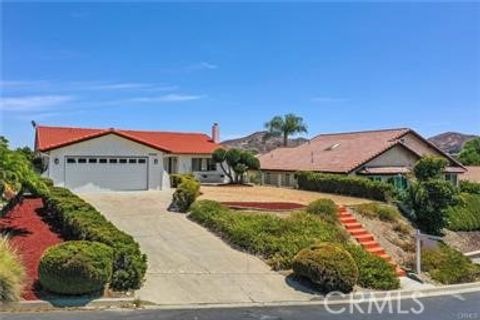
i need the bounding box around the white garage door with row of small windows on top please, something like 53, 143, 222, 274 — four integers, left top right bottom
65, 156, 148, 191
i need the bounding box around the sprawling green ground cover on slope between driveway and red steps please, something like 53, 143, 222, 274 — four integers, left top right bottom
189, 200, 399, 290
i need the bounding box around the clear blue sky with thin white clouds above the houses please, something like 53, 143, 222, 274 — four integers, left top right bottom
0, 2, 480, 146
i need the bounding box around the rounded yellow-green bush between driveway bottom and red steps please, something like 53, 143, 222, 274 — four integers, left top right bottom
292, 243, 358, 293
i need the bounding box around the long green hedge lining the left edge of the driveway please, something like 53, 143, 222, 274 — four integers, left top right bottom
40, 187, 147, 290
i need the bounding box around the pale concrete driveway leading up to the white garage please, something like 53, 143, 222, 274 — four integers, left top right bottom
80, 191, 314, 304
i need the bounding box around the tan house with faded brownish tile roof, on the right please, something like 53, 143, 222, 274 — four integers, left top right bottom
258, 128, 465, 188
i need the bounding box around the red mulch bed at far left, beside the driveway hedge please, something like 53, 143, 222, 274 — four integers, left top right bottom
0, 198, 63, 300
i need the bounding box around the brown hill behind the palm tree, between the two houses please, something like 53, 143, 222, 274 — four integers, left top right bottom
221, 131, 308, 153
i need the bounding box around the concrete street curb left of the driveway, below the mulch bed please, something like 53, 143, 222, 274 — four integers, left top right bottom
0, 298, 138, 313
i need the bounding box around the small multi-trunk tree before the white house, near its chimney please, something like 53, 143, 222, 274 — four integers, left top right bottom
212, 148, 260, 183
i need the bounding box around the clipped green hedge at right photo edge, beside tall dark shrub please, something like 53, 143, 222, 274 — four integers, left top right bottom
447, 193, 480, 231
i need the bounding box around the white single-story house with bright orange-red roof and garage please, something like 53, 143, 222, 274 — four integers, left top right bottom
35, 124, 224, 192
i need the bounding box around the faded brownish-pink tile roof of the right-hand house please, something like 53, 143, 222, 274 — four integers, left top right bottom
258, 128, 464, 173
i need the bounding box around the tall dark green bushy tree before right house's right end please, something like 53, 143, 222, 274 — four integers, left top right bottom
406, 157, 458, 234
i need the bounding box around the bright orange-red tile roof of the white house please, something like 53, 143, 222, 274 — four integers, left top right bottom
35, 126, 220, 154
